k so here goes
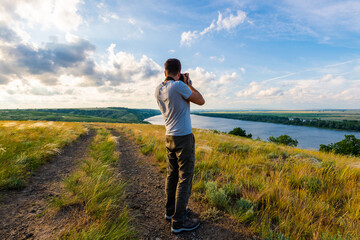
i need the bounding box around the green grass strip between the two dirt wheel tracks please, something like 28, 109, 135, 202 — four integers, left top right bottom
53, 129, 135, 240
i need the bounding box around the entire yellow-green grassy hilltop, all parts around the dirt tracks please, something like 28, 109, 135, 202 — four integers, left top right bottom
0, 121, 360, 240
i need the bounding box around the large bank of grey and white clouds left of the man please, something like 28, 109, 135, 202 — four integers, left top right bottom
0, 1, 163, 108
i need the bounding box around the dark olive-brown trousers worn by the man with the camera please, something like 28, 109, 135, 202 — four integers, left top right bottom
165, 133, 195, 222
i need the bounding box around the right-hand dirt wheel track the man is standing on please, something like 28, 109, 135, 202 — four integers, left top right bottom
113, 131, 258, 240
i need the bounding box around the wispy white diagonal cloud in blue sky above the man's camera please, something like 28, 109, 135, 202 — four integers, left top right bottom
180, 10, 246, 46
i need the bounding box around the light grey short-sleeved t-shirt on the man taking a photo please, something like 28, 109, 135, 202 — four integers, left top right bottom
155, 80, 192, 136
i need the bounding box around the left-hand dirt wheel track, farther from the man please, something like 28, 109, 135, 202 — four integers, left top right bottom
0, 130, 95, 239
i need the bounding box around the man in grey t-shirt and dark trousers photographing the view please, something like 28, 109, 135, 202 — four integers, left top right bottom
155, 58, 205, 233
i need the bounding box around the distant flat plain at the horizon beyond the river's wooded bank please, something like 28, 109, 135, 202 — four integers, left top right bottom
199, 110, 360, 120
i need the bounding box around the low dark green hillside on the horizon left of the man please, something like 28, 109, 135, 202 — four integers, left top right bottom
0, 107, 160, 123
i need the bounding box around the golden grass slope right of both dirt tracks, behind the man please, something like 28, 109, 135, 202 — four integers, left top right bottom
114, 124, 360, 240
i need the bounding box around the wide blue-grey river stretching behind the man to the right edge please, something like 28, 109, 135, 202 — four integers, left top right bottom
145, 114, 360, 150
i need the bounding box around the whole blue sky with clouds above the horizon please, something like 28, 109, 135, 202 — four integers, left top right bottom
0, 0, 360, 110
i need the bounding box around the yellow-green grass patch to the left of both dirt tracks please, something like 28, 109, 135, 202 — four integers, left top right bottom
0, 121, 87, 189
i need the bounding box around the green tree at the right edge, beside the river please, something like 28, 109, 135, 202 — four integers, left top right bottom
319, 135, 360, 156
